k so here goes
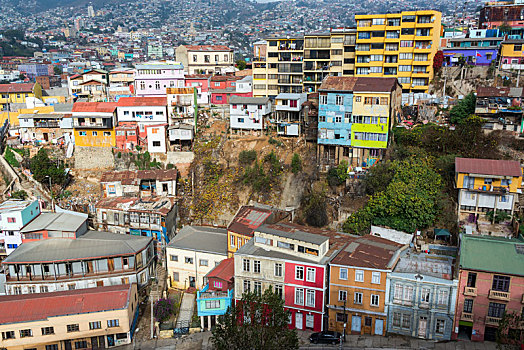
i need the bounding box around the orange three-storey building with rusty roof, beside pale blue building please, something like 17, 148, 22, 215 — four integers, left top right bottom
327, 235, 402, 335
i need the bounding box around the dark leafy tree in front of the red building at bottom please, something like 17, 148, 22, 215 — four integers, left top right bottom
211, 287, 298, 350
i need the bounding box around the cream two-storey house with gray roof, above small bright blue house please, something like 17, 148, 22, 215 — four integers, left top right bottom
166, 226, 227, 290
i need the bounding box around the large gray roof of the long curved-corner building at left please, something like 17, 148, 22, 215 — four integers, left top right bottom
2, 231, 153, 264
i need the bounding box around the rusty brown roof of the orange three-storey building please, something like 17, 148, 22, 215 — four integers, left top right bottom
331, 235, 402, 270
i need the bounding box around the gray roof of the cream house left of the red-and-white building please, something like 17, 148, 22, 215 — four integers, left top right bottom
167, 226, 227, 255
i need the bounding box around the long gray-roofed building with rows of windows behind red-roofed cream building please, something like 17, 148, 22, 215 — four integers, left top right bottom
2, 231, 155, 294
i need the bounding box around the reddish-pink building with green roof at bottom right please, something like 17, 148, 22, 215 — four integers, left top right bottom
452, 235, 524, 341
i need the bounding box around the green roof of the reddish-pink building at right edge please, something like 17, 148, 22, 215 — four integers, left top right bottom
460, 234, 524, 276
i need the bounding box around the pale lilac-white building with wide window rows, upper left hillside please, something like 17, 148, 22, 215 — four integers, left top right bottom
135, 61, 184, 97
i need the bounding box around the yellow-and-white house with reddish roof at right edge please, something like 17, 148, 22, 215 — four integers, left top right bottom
455, 158, 522, 226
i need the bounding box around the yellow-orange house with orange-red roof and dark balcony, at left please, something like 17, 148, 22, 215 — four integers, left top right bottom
72, 102, 116, 147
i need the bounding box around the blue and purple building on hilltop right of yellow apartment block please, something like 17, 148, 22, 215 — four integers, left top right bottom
442, 38, 503, 66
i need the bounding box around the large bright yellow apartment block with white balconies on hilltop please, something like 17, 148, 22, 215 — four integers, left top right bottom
355, 10, 441, 92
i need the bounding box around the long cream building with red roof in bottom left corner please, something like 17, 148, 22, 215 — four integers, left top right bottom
0, 284, 139, 350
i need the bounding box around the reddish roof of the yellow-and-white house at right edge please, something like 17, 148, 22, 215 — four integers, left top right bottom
455, 157, 522, 176
